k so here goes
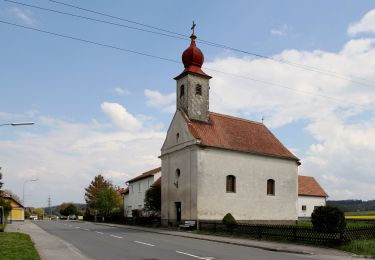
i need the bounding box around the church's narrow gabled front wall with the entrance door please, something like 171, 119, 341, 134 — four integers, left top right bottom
161, 111, 198, 221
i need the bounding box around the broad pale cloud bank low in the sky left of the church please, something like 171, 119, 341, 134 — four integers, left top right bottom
0, 106, 165, 206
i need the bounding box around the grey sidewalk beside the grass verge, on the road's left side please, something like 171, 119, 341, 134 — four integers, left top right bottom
5, 221, 88, 260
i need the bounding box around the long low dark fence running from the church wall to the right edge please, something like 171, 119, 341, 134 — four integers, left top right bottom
199, 221, 375, 244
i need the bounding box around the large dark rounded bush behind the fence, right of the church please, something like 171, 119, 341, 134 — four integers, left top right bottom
311, 206, 346, 232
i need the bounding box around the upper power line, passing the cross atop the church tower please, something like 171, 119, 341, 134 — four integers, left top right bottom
39, 0, 375, 87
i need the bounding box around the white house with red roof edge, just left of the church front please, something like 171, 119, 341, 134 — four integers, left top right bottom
123, 167, 161, 217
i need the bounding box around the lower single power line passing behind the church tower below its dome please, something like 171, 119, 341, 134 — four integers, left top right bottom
0, 20, 370, 107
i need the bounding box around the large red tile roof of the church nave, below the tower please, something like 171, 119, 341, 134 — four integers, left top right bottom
184, 112, 299, 161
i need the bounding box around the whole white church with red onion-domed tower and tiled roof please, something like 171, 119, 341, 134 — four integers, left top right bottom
160, 30, 300, 226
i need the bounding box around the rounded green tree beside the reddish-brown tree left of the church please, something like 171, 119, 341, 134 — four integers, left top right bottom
94, 185, 121, 216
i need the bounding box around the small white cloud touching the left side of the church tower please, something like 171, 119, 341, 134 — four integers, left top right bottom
144, 89, 176, 113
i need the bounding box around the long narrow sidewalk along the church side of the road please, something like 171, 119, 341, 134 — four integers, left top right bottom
90, 222, 362, 260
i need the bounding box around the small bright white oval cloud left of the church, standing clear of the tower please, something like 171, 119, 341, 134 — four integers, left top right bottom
101, 102, 142, 131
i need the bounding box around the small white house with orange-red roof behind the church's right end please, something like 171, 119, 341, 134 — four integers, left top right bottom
298, 176, 328, 218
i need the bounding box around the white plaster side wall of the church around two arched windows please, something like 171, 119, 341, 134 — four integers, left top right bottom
197, 148, 298, 221
